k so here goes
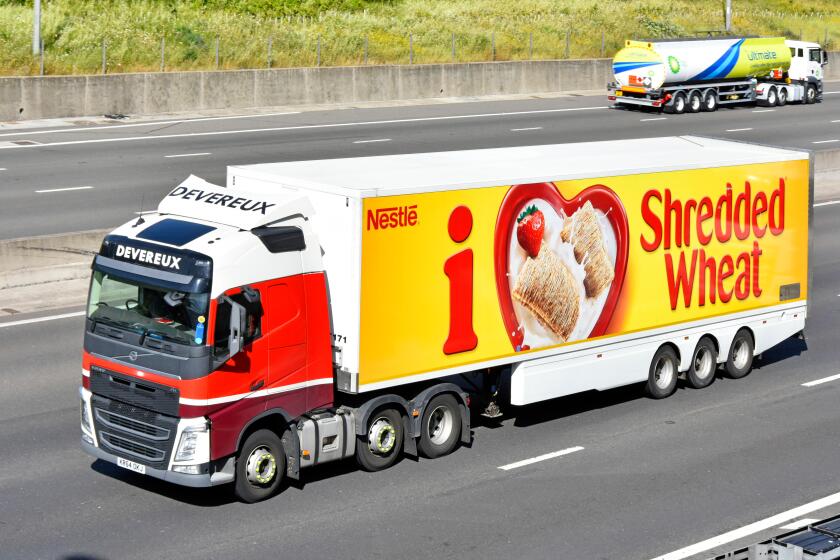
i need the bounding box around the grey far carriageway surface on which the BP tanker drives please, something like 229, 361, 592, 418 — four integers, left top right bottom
0, 82, 840, 239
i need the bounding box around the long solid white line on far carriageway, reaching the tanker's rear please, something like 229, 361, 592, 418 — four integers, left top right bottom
0, 106, 608, 150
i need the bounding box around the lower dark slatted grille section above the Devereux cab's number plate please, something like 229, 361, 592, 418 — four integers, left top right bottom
91, 394, 178, 469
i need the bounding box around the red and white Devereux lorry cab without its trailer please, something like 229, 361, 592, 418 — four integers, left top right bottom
80, 177, 333, 496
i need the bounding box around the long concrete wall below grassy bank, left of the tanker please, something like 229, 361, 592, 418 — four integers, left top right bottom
0, 59, 612, 121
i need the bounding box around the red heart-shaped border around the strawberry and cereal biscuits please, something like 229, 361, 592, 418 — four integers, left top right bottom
494, 183, 629, 351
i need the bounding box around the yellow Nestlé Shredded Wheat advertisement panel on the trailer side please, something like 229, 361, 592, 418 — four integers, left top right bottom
359, 161, 809, 385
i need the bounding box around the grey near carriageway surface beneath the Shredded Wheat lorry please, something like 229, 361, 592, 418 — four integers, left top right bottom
0, 204, 840, 560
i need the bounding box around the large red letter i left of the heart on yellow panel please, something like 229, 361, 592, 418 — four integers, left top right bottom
443, 206, 478, 354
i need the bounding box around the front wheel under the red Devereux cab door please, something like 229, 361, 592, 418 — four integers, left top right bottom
234, 430, 286, 504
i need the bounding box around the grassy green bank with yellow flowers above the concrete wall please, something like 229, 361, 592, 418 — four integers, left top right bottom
0, 0, 840, 75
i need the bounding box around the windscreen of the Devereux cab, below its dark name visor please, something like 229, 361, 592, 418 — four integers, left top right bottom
87, 271, 209, 346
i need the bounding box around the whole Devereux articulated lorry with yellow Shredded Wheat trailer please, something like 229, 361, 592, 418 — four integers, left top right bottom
79, 137, 812, 502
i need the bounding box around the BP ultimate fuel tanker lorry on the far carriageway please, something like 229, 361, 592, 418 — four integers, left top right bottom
607, 37, 828, 114
